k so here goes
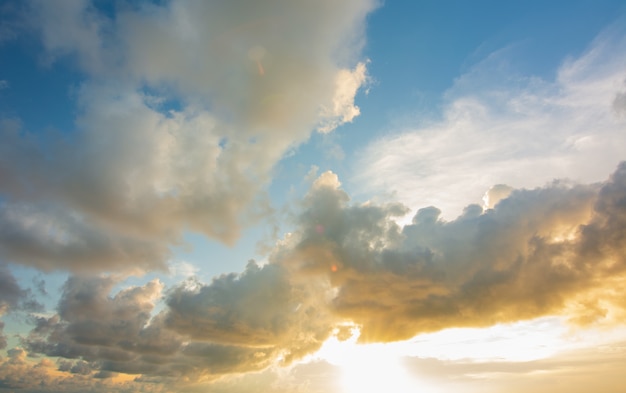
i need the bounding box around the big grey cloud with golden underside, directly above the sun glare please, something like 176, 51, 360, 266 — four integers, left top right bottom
270, 164, 626, 342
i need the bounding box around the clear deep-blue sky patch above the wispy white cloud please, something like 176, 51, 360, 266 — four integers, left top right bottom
346, 0, 626, 136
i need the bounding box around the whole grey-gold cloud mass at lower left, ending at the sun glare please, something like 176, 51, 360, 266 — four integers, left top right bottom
23, 262, 333, 383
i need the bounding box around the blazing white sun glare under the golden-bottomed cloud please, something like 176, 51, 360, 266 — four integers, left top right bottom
315, 317, 626, 393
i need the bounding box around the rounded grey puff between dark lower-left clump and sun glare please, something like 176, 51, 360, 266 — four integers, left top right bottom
166, 262, 329, 349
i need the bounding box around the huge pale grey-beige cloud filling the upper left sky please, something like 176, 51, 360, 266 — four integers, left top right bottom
0, 0, 375, 271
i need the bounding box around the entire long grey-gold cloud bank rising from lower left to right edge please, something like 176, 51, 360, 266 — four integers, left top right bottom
17, 163, 626, 381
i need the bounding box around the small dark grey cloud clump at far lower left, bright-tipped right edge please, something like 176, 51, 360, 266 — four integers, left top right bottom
24, 277, 181, 373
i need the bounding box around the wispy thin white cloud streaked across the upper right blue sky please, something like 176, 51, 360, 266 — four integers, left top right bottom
354, 24, 626, 219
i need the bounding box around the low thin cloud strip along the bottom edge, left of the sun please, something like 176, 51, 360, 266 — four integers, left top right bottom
0, 348, 339, 393
